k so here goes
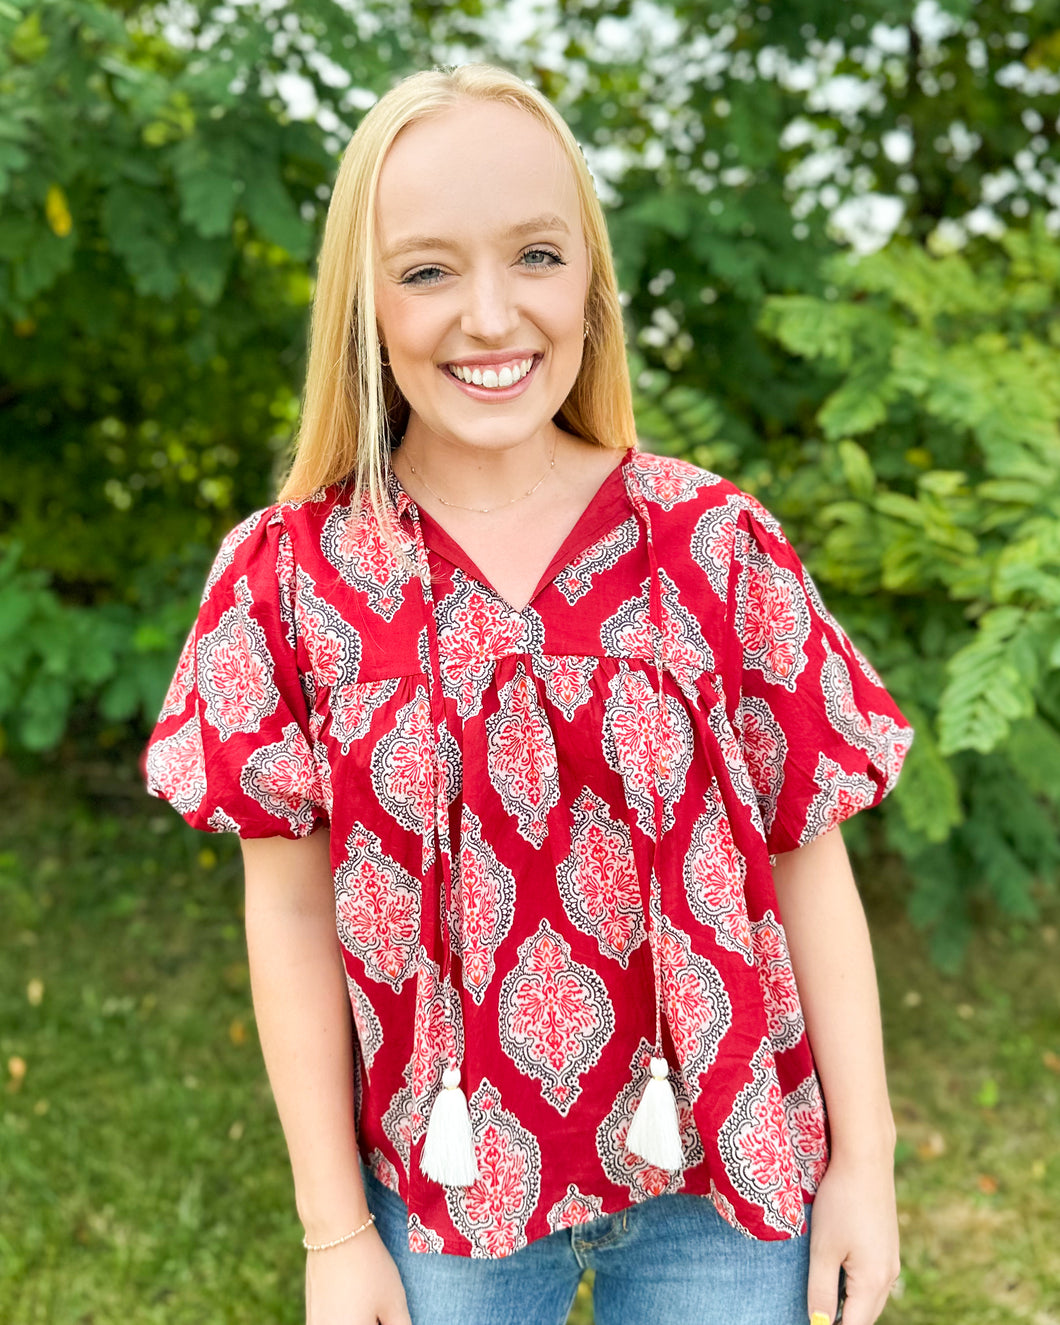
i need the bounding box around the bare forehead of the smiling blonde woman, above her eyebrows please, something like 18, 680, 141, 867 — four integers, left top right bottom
376, 101, 582, 248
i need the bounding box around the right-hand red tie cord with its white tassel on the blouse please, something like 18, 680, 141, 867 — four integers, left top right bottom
624, 462, 684, 1171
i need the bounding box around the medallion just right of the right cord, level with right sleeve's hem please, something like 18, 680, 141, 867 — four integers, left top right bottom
685, 782, 753, 965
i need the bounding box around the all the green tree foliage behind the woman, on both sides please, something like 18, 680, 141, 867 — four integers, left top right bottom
0, 0, 1060, 961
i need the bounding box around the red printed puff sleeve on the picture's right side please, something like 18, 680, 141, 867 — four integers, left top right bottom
729, 502, 913, 853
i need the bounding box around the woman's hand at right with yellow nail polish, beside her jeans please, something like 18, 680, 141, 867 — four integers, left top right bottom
807, 1154, 901, 1325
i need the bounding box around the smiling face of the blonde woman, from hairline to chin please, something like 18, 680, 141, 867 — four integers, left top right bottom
375, 101, 588, 461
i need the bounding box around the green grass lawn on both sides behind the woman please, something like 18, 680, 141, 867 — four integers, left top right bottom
0, 771, 1060, 1325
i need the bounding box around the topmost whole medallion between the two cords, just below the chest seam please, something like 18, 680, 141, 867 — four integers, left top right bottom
486, 663, 559, 847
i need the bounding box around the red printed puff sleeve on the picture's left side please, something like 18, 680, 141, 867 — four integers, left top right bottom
140, 505, 330, 837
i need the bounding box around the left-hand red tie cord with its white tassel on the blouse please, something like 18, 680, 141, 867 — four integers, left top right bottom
412, 506, 478, 1187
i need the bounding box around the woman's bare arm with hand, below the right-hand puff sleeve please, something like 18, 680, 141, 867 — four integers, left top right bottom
774, 828, 900, 1325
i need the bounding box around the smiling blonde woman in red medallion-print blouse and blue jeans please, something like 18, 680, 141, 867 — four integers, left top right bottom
146, 65, 912, 1325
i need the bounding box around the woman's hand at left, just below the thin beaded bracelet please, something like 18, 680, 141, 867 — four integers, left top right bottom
306, 1228, 412, 1325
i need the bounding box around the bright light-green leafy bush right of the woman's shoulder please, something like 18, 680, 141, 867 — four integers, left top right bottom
633, 213, 1060, 965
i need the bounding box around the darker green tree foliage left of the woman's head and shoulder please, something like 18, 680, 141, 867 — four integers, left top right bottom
0, 0, 405, 750
